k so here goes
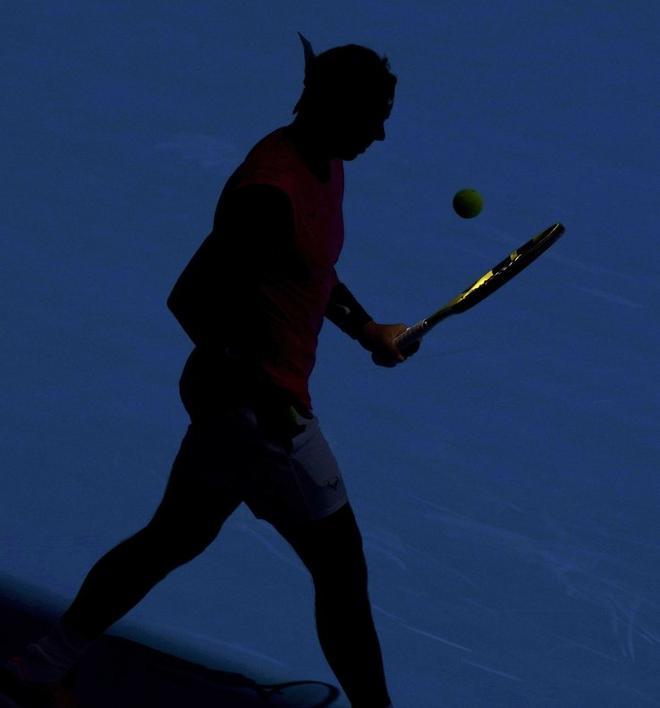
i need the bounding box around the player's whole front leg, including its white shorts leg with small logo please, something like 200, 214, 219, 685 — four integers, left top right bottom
240, 404, 390, 708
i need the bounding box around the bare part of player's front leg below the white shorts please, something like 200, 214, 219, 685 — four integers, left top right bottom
274, 503, 391, 708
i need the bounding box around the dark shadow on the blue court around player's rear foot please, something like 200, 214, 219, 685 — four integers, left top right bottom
0, 577, 340, 708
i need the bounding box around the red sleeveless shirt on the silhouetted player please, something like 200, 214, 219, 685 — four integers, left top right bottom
214, 128, 344, 411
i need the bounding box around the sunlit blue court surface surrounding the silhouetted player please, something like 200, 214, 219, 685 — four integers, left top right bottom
0, 0, 660, 708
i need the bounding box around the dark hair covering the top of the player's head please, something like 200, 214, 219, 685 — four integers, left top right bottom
293, 44, 397, 113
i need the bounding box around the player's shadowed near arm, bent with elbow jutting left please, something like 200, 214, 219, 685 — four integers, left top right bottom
167, 185, 296, 428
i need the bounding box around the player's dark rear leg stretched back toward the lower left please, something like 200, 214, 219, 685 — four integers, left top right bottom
6, 418, 241, 683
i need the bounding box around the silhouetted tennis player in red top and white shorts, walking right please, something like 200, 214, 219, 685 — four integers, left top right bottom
5, 35, 419, 708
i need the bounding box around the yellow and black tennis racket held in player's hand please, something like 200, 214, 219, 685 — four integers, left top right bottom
394, 223, 566, 353
